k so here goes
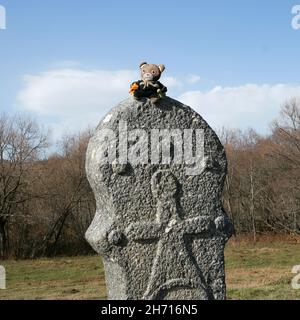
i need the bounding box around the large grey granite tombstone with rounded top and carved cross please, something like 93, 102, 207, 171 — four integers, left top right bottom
86, 98, 233, 300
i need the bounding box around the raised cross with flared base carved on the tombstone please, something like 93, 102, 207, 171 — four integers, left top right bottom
126, 170, 215, 300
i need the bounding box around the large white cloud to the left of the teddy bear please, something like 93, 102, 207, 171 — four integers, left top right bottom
17, 69, 138, 138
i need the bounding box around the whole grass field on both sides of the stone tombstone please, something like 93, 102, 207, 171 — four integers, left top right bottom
0, 238, 300, 299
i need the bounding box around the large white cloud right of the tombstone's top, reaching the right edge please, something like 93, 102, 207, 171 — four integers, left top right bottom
178, 84, 300, 132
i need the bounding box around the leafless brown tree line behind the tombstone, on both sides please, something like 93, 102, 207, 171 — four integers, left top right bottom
0, 99, 300, 258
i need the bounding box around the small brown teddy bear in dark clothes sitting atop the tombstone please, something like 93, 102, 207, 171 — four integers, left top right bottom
129, 62, 167, 103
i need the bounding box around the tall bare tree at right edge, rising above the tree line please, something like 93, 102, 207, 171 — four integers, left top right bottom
272, 98, 300, 234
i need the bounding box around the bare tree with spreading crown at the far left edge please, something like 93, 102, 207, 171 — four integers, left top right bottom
0, 114, 47, 257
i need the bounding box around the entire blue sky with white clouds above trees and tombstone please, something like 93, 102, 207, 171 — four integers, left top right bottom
0, 0, 300, 136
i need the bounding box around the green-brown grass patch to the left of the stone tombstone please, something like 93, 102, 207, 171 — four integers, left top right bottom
0, 256, 106, 299
